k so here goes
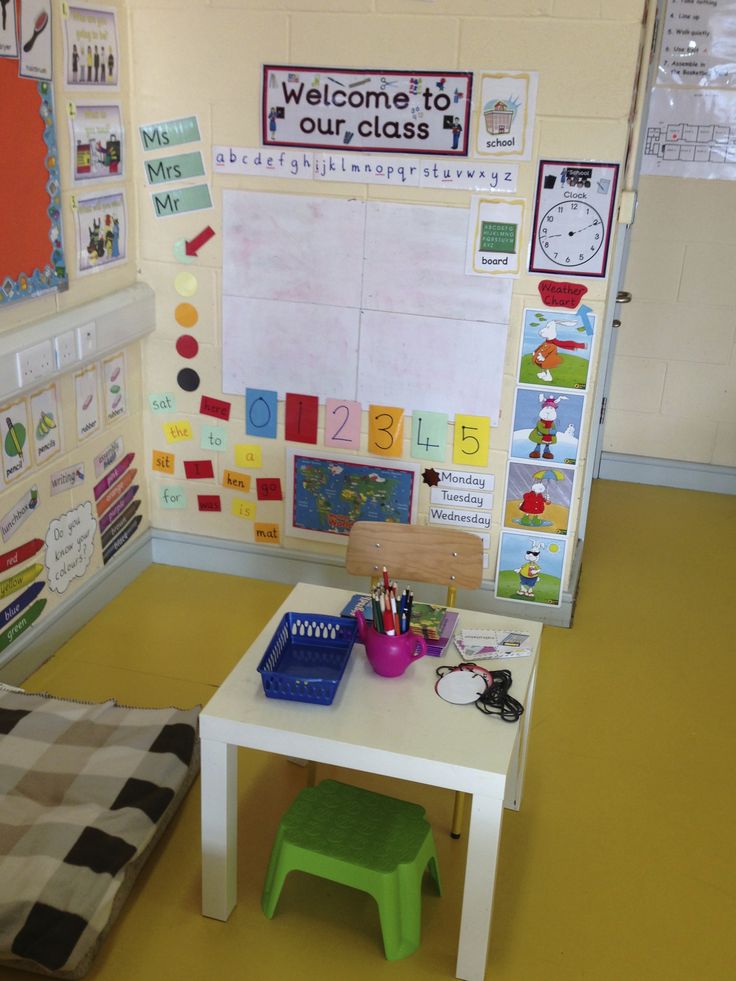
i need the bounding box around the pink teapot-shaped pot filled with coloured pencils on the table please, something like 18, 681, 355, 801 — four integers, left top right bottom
355, 580, 427, 678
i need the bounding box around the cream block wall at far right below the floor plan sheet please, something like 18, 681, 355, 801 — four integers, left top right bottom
603, 176, 736, 467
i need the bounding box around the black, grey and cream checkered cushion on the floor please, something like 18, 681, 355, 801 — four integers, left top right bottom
0, 690, 199, 978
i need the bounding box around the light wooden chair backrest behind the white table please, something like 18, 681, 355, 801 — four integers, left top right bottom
345, 521, 483, 606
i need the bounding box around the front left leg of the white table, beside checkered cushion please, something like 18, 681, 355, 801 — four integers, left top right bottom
201, 739, 238, 920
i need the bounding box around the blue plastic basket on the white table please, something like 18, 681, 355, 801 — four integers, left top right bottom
258, 613, 358, 705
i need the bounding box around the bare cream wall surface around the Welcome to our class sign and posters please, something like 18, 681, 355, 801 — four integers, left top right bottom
128, 0, 645, 578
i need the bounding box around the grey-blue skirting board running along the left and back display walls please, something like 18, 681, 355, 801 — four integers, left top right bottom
0, 529, 582, 685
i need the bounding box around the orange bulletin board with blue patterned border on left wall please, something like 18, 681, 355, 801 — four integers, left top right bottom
0, 58, 68, 307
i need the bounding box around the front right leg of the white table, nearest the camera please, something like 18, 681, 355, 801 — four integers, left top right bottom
455, 793, 503, 981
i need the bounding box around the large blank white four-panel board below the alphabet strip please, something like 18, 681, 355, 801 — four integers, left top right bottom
222, 191, 511, 424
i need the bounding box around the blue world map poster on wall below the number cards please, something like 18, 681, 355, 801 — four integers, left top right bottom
289, 451, 418, 537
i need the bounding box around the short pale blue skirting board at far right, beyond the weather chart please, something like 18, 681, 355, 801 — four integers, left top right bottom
598, 452, 736, 494
